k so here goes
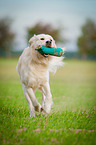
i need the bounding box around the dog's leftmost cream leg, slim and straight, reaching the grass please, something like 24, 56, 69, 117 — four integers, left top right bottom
23, 85, 35, 117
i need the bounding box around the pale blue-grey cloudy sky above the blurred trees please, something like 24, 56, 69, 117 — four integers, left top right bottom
0, 0, 96, 51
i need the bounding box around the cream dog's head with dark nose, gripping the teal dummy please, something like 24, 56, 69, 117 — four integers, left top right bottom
29, 34, 56, 61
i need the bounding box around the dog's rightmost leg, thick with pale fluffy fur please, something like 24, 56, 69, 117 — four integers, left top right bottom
43, 82, 52, 113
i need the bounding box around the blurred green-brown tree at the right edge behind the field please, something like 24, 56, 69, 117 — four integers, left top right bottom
77, 19, 96, 58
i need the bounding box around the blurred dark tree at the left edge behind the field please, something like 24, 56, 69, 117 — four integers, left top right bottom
0, 18, 15, 57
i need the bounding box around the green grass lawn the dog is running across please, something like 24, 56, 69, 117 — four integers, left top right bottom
0, 59, 96, 145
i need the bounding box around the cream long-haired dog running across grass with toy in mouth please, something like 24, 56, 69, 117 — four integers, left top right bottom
16, 34, 63, 117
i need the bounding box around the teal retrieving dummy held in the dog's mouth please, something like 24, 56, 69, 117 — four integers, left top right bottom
35, 46, 63, 57
